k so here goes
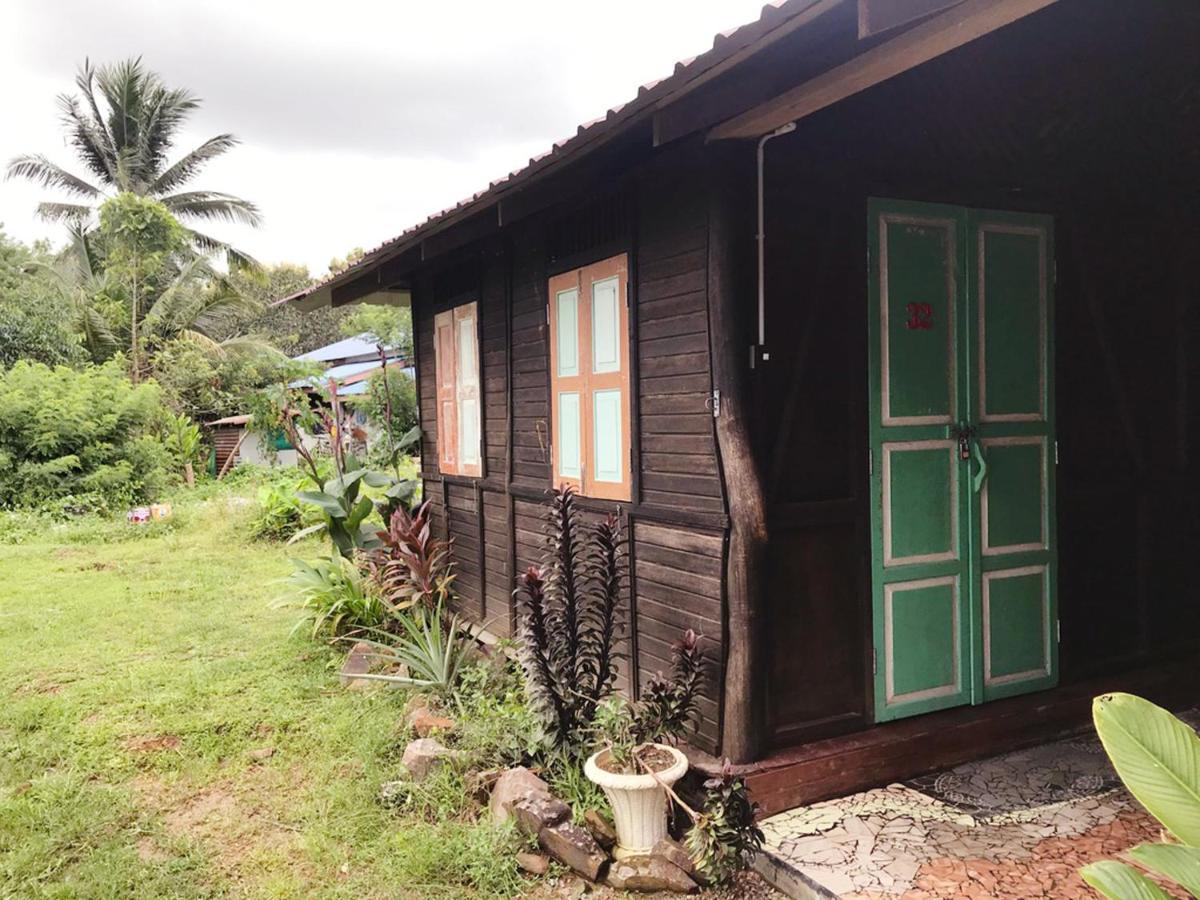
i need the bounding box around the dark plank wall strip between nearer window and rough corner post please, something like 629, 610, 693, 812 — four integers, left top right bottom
632, 150, 725, 746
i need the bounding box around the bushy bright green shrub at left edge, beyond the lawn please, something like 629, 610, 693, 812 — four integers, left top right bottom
0, 362, 172, 511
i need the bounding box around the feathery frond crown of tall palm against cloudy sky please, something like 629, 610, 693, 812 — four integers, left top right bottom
7, 58, 262, 268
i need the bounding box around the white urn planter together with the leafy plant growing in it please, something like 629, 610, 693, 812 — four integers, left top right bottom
583, 630, 701, 859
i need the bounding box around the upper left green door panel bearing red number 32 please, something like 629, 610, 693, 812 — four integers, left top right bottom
880, 214, 958, 425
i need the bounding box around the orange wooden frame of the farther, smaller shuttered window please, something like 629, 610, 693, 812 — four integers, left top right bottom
433, 300, 484, 478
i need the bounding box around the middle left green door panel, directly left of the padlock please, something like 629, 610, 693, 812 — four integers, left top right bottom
882, 440, 959, 566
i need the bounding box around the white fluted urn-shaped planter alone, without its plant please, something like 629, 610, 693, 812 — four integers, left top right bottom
583, 744, 688, 859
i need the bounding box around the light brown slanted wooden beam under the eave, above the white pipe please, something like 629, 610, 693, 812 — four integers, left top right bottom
708, 0, 1057, 140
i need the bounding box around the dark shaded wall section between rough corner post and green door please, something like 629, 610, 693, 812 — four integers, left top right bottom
755, 172, 870, 746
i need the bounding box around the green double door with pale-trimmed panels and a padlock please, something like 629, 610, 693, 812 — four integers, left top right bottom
869, 200, 1058, 721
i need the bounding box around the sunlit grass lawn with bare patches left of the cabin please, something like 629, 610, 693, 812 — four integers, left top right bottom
0, 497, 521, 898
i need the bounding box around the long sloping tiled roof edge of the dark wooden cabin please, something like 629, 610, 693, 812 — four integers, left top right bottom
276, 0, 828, 304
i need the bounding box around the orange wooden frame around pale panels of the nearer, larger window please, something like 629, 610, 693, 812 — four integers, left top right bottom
547, 253, 634, 502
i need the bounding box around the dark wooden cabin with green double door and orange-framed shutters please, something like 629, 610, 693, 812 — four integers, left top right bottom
283, 0, 1200, 810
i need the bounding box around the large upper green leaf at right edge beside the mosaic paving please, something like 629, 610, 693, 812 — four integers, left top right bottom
1092, 694, 1200, 847
